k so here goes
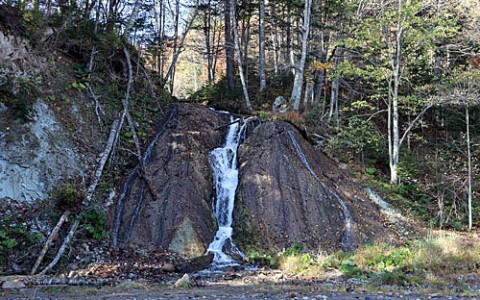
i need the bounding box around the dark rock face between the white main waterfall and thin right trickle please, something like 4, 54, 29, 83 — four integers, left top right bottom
234, 122, 343, 252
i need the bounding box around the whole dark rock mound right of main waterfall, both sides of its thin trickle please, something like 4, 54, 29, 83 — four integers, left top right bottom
234, 121, 390, 252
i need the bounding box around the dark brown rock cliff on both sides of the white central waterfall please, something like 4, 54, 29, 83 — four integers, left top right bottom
112, 104, 391, 258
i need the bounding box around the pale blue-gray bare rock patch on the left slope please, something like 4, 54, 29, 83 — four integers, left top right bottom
0, 99, 85, 203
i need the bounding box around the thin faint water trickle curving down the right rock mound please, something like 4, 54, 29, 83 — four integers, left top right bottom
287, 130, 354, 251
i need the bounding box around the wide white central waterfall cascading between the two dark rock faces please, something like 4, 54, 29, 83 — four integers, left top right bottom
207, 116, 247, 267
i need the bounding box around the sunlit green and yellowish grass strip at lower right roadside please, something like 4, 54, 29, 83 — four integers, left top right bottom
270, 232, 480, 286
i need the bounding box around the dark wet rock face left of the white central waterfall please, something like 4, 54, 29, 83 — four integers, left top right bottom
113, 104, 228, 258
